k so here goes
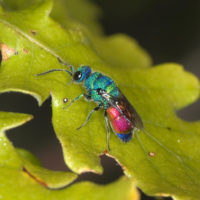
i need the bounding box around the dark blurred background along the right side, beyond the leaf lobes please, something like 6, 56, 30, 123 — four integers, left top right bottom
95, 0, 200, 121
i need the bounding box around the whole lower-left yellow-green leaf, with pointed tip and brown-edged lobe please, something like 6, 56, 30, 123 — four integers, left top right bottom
0, 112, 138, 200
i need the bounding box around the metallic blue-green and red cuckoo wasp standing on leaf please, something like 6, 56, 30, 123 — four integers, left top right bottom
37, 58, 143, 151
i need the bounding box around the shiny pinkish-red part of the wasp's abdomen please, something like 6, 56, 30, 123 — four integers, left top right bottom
106, 106, 133, 134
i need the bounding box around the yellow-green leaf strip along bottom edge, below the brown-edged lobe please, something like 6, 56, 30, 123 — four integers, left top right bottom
0, 168, 137, 200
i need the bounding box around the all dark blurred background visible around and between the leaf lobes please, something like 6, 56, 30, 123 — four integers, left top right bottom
0, 0, 200, 200
